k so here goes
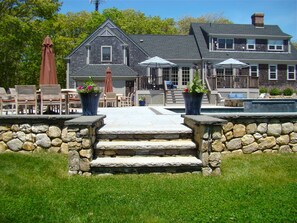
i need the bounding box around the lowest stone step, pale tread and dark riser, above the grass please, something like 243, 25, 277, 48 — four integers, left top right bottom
91, 156, 202, 173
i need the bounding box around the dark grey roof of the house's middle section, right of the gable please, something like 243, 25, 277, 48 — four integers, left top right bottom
129, 35, 200, 60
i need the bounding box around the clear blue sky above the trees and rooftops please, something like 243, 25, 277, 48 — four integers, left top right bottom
60, 0, 297, 42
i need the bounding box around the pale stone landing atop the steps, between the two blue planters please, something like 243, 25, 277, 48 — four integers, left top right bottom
98, 106, 190, 133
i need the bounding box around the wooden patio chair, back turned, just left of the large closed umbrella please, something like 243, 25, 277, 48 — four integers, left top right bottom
15, 85, 38, 115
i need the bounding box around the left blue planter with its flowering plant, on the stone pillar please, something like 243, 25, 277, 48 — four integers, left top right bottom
77, 77, 101, 115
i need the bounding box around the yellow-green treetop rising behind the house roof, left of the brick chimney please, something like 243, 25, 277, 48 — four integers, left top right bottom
177, 14, 232, 34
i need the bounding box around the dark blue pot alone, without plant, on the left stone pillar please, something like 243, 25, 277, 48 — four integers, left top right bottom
79, 93, 100, 116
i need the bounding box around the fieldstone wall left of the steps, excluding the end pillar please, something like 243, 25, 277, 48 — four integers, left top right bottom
0, 116, 75, 154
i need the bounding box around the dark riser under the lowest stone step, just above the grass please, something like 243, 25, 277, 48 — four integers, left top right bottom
91, 166, 201, 174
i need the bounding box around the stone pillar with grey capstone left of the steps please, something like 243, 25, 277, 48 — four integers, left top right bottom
65, 116, 105, 176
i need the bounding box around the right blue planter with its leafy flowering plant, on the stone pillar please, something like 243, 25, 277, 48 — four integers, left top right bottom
183, 72, 208, 115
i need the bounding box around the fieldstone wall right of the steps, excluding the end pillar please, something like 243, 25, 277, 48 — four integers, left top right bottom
212, 113, 297, 154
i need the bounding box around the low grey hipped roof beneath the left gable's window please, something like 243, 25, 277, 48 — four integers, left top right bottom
72, 64, 137, 78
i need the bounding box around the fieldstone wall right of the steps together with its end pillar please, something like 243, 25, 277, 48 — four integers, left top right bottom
184, 113, 297, 175
